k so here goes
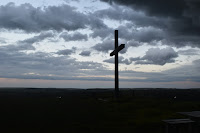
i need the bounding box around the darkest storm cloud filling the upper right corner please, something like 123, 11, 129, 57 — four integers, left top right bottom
101, 0, 200, 47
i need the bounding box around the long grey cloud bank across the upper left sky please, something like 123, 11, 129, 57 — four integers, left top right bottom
0, 3, 107, 32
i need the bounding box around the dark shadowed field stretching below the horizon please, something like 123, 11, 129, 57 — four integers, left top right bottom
0, 88, 200, 133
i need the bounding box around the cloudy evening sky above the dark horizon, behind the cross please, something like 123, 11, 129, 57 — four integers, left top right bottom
0, 0, 200, 88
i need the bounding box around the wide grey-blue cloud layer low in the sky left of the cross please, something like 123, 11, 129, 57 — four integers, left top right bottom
0, 44, 106, 80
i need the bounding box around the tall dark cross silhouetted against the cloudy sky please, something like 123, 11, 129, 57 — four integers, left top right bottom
110, 30, 125, 98
